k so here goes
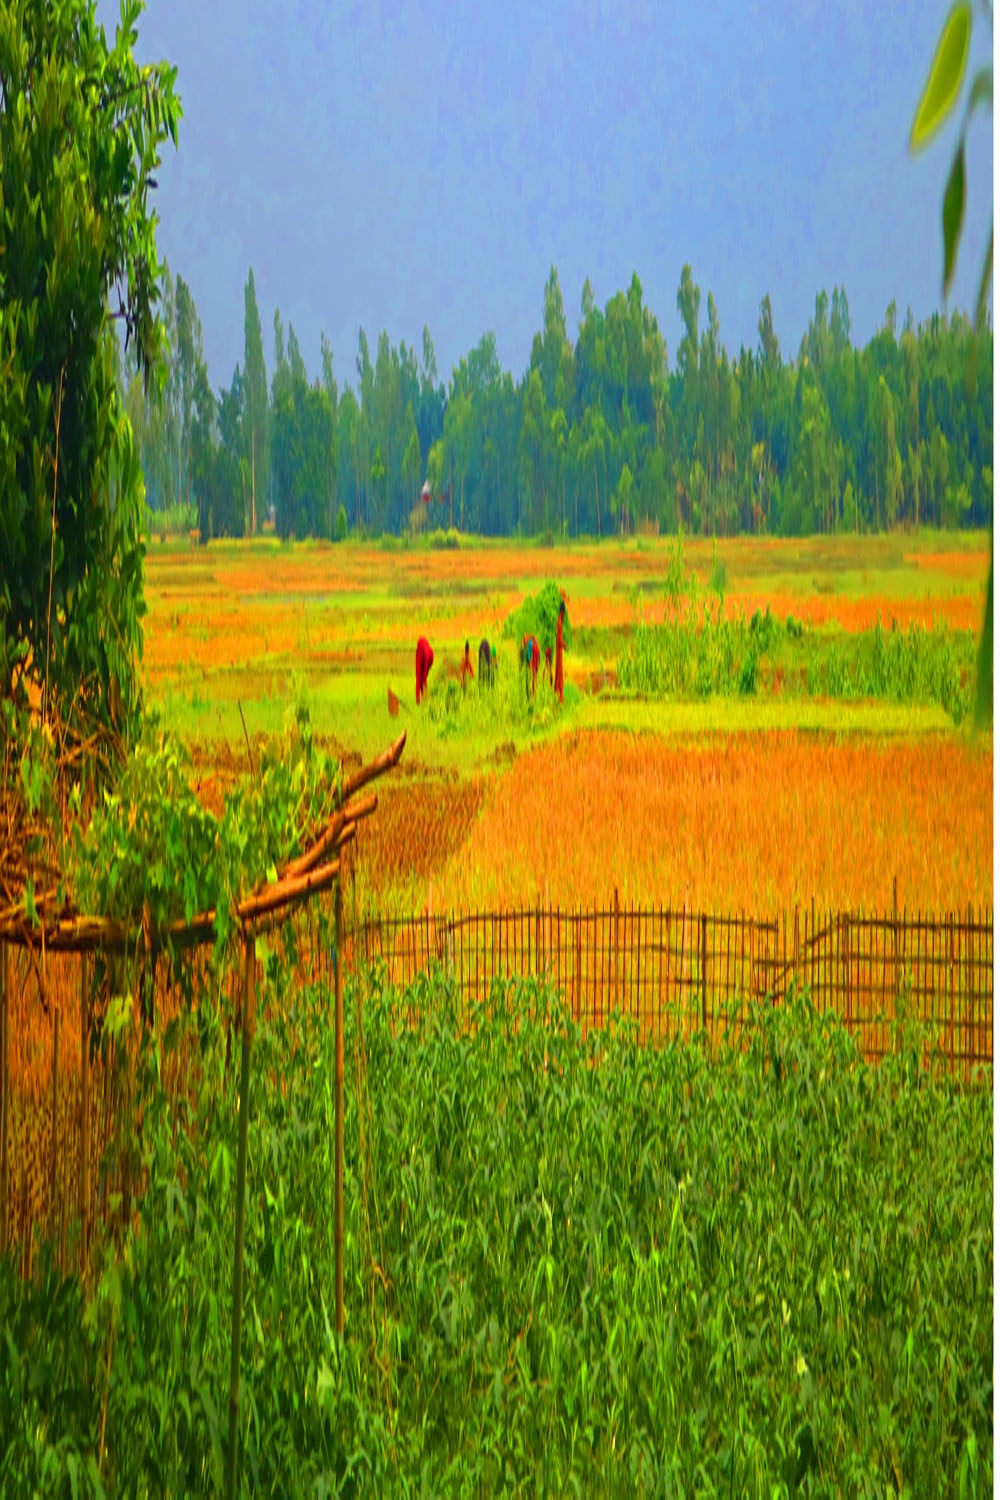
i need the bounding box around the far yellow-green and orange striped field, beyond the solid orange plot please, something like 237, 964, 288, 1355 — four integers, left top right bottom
145, 533, 990, 762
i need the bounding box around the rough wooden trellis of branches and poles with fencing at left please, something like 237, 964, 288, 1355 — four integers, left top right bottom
0, 734, 406, 1496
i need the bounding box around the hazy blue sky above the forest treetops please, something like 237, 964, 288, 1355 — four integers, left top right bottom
97, 0, 993, 399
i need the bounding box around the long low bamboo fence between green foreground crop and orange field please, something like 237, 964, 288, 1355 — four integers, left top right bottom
345, 899, 993, 1080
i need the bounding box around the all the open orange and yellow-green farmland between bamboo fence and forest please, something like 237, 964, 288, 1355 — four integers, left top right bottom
145, 533, 993, 914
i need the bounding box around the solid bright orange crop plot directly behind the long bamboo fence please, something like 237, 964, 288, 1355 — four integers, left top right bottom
425, 731, 993, 915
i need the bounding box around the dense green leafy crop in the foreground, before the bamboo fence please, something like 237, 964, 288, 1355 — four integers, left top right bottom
0, 981, 994, 1496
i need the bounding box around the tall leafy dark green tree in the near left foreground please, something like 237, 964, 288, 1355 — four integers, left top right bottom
0, 0, 180, 738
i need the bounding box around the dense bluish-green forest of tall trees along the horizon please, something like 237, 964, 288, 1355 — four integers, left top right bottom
124, 266, 993, 540
